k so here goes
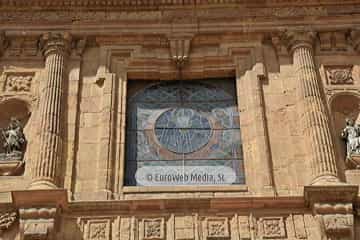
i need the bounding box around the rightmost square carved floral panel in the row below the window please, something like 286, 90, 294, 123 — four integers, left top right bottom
258, 217, 286, 239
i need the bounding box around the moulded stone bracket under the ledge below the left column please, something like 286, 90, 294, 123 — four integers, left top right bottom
19, 208, 58, 240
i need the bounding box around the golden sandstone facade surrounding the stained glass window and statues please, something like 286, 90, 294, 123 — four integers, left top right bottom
0, 0, 360, 240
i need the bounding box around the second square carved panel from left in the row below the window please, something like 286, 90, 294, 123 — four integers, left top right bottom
142, 218, 165, 240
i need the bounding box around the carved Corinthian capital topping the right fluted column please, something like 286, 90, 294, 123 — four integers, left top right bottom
283, 30, 317, 53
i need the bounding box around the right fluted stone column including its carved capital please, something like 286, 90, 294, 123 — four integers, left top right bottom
286, 32, 339, 185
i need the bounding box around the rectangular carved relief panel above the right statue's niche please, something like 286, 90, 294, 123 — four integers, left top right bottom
325, 66, 354, 85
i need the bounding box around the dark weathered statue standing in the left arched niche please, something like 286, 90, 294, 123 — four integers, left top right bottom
0, 118, 26, 161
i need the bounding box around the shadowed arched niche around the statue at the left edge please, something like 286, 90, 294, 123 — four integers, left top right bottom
0, 97, 31, 176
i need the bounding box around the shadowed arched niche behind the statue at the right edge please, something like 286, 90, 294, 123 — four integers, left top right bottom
329, 92, 360, 168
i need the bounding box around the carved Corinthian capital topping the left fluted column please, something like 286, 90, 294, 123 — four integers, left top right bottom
40, 33, 72, 57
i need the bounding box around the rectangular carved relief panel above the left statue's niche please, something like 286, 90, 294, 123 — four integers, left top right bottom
5, 73, 34, 92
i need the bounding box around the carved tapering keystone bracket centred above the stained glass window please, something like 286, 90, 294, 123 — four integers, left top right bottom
169, 35, 193, 69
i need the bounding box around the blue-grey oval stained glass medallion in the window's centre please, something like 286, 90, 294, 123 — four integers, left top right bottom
155, 108, 212, 154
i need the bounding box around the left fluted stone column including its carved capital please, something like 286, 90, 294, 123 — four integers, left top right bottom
30, 33, 71, 189
